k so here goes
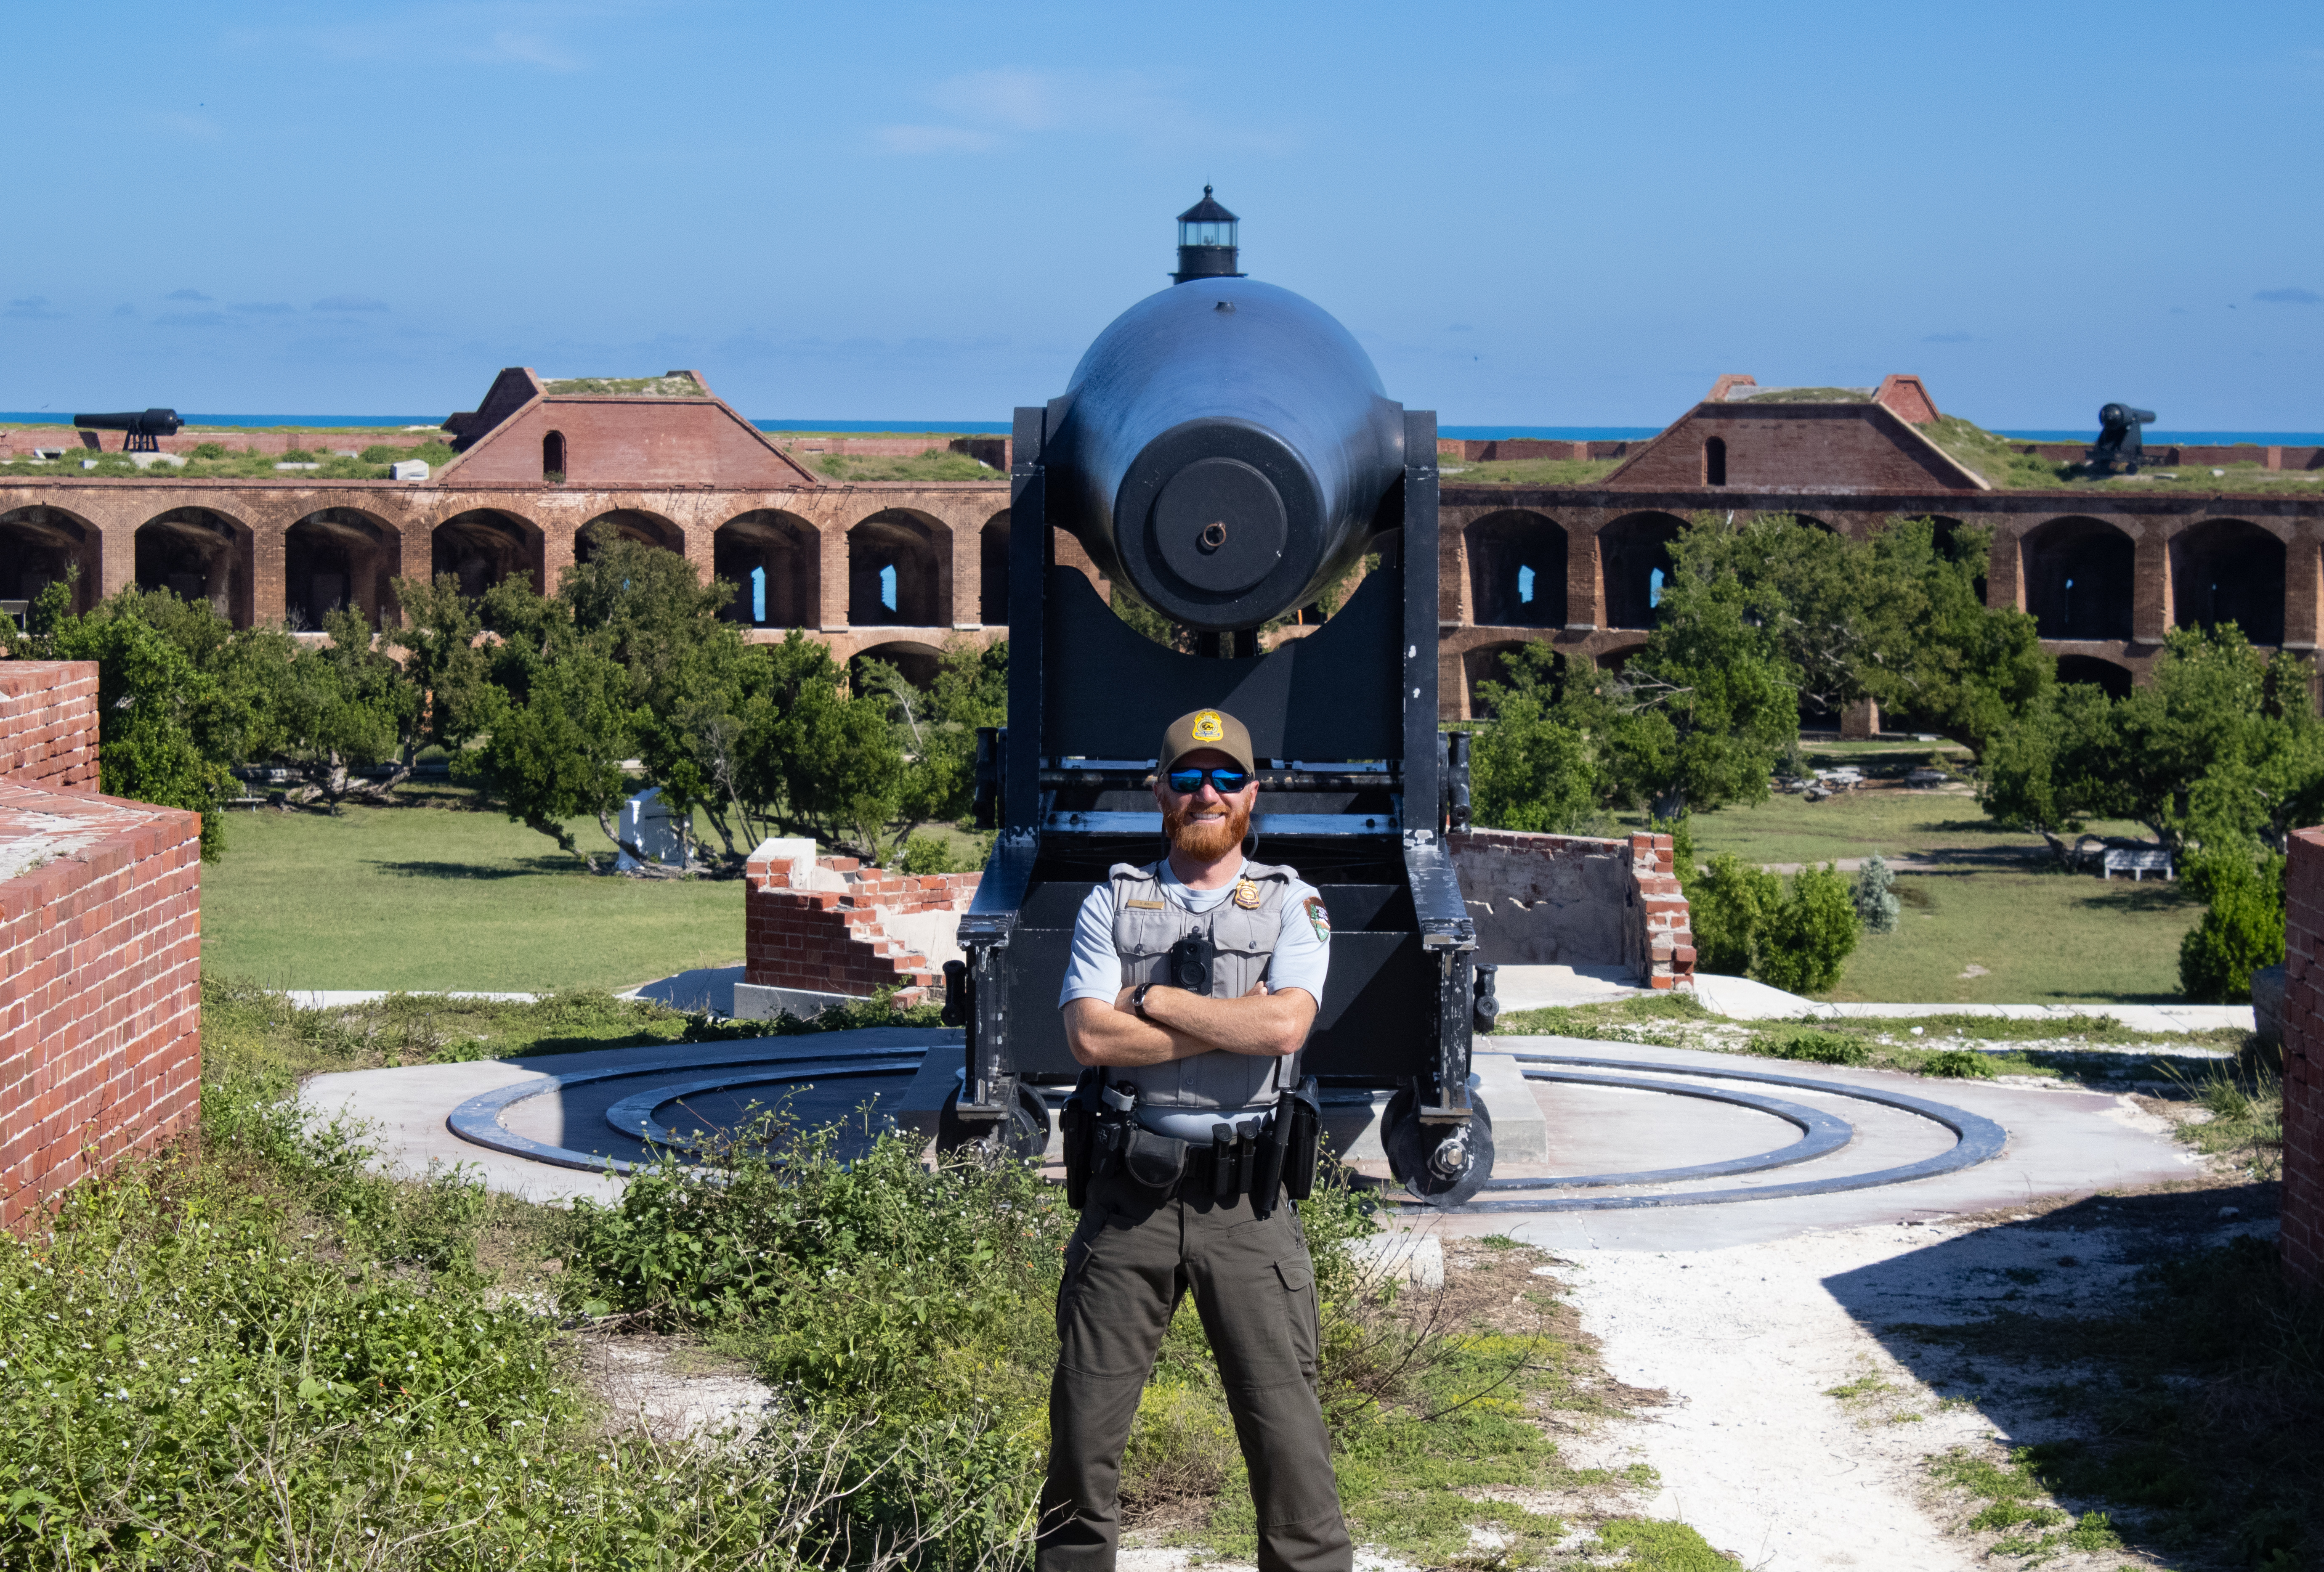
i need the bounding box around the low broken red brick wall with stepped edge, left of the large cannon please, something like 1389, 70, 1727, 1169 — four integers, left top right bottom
741, 852, 983, 1008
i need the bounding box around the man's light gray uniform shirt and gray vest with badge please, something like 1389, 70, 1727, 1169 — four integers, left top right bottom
1057, 859, 1332, 1140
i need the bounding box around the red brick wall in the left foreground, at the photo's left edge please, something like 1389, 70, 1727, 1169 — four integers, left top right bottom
0, 662, 202, 1228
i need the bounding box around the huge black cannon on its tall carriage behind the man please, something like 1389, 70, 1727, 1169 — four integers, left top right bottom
939, 193, 1494, 1203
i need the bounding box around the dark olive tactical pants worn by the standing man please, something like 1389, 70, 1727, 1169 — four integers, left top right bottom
1036, 1175, 1355, 1572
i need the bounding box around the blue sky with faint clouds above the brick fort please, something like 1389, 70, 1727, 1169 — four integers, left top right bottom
0, 0, 2324, 429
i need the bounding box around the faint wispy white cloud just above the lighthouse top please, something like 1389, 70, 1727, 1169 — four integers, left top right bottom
871, 70, 1299, 153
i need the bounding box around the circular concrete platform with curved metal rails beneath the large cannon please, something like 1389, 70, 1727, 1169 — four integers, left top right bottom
302, 1029, 2189, 1235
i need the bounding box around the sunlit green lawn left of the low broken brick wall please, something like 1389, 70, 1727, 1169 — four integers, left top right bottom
202, 792, 741, 991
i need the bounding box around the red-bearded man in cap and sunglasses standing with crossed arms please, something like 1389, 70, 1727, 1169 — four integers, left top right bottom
1036, 710, 1355, 1572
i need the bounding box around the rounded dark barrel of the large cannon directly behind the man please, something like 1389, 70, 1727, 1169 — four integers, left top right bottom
1044, 278, 1404, 631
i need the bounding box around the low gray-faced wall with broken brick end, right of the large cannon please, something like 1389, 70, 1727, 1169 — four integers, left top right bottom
1448, 829, 1694, 989
